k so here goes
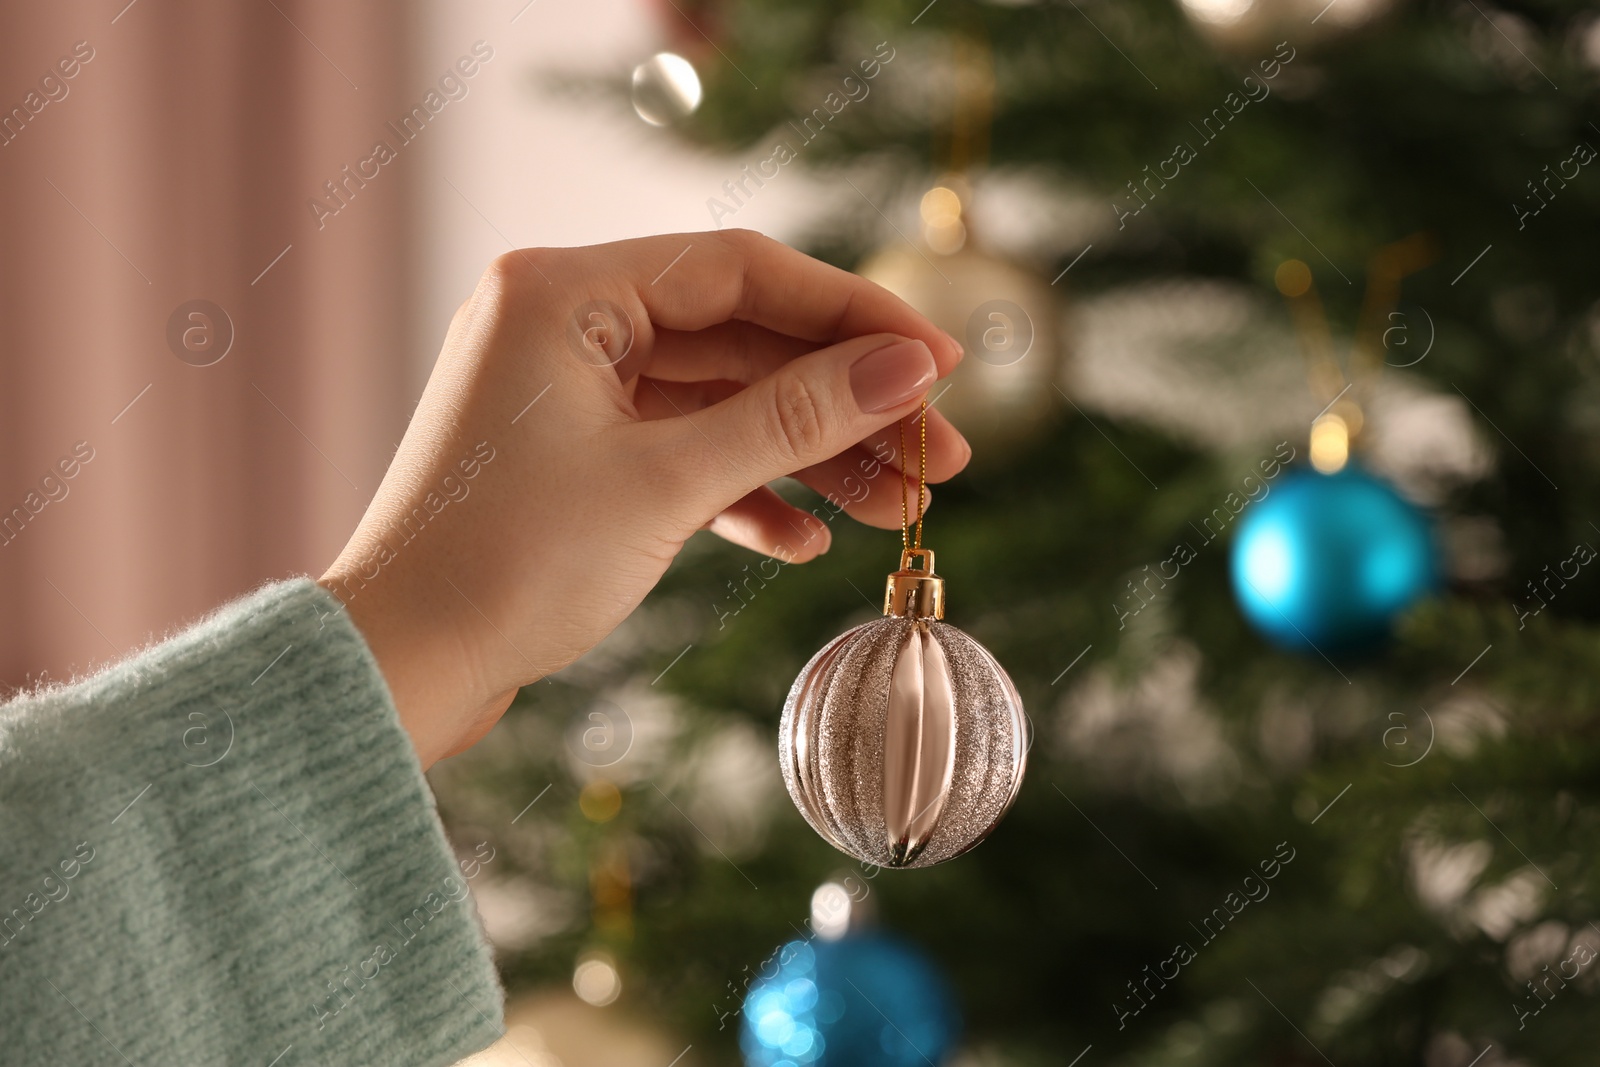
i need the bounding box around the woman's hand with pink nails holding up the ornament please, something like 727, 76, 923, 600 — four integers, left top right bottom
312, 230, 971, 766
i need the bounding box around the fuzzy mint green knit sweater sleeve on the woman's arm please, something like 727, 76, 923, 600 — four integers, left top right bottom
0, 579, 504, 1067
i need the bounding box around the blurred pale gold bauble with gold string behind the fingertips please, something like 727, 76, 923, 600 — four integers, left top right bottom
856, 37, 1061, 464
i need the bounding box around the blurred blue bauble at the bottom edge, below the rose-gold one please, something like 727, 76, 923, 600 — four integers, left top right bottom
739, 933, 960, 1067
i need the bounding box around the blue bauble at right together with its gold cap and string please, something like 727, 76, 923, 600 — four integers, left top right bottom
1232, 246, 1440, 656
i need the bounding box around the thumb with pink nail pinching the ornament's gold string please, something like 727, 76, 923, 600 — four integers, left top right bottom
665, 333, 939, 507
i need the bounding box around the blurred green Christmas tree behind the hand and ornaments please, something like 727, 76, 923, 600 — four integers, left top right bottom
434, 0, 1600, 1067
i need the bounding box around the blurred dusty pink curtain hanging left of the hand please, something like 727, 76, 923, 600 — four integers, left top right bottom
0, 0, 418, 694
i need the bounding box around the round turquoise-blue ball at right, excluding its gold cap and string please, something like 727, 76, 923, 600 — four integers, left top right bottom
1232, 464, 1438, 654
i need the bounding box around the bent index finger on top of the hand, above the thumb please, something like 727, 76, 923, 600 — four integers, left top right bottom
585, 230, 962, 376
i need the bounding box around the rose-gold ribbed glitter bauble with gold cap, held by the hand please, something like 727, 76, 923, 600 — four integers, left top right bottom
779, 547, 1029, 867
